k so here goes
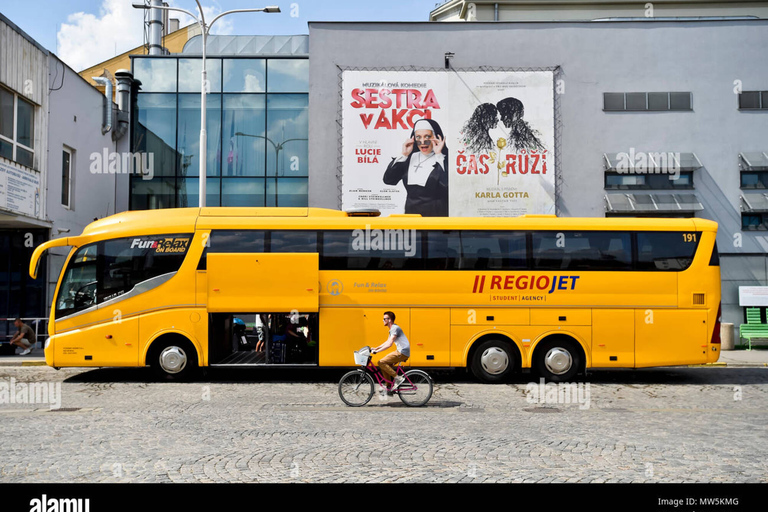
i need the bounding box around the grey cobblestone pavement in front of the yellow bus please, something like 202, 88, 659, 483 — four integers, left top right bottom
0, 367, 768, 482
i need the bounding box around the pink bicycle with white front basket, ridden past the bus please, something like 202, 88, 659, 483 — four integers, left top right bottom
339, 347, 432, 407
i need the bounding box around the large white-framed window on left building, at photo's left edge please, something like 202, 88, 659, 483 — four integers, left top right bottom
0, 87, 35, 168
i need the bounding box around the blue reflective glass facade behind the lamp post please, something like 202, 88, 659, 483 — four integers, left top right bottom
130, 56, 309, 210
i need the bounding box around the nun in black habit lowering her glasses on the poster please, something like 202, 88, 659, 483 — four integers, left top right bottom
384, 119, 448, 217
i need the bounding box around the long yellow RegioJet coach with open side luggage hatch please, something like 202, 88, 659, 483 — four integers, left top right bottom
25, 207, 720, 382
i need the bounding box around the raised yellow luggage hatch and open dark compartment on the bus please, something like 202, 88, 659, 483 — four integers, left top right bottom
207, 253, 319, 365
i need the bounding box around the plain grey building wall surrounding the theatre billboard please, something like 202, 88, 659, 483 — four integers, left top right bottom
309, 20, 768, 323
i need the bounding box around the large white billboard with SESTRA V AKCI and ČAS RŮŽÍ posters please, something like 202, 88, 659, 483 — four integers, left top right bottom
341, 70, 555, 217
